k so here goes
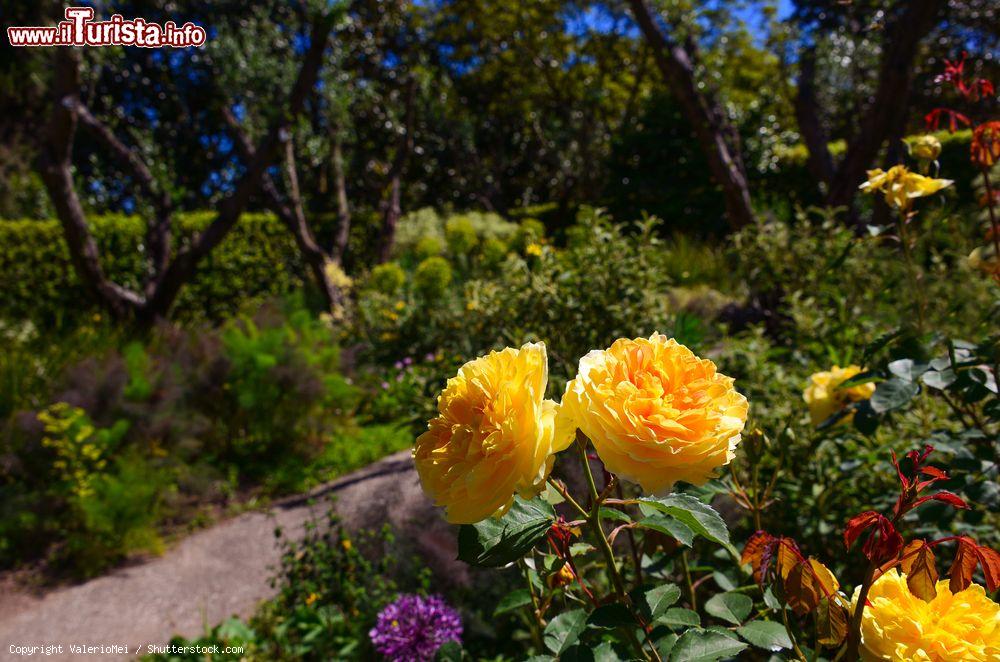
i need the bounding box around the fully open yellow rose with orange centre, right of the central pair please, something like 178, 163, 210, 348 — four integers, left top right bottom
560, 333, 747, 493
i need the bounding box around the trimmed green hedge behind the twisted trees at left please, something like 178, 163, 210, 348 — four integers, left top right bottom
0, 212, 307, 325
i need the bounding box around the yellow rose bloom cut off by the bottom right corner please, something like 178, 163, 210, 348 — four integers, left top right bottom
852, 568, 1000, 662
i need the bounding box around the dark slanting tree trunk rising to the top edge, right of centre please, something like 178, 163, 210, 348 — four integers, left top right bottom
629, 0, 754, 230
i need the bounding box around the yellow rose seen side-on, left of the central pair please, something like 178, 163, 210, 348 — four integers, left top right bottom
413, 343, 572, 524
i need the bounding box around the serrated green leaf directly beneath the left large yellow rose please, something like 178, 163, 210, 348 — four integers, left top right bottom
458, 497, 555, 568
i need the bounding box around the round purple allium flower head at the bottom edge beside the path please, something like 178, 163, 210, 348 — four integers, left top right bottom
368, 595, 462, 662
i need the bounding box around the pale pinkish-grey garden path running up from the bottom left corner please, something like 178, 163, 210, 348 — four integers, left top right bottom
0, 451, 455, 660
